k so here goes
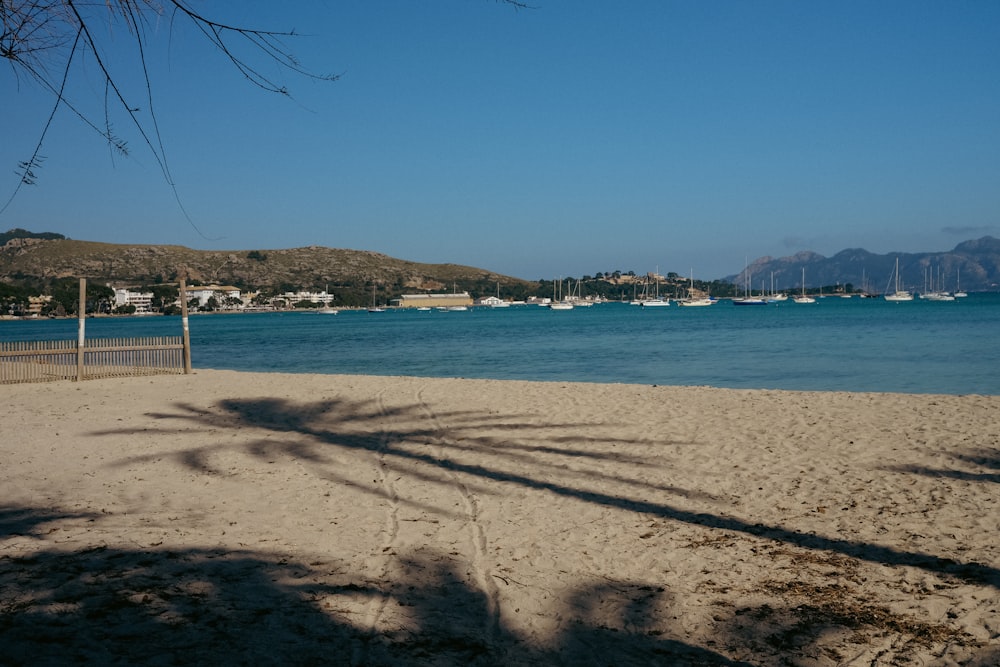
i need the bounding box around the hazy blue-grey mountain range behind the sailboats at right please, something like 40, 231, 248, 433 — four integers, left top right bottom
724, 236, 1000, 293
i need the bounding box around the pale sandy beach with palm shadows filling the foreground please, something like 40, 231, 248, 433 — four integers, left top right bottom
0, 371, 1000, 667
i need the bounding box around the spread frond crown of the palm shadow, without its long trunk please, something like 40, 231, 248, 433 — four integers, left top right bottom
107, 398, 715, 500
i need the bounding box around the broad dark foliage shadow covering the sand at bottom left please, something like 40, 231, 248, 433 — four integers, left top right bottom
0, 507, 746, 667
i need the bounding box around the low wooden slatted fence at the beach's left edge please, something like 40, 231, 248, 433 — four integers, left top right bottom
0, 336, 186, 384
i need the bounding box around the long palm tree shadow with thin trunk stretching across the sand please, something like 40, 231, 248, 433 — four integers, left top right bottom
125, 399, 1000, 588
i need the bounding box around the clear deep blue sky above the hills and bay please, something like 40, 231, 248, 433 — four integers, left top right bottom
0, 0, 1000, 279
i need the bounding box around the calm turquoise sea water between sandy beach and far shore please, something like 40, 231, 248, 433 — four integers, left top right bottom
0, 294, 1000, 394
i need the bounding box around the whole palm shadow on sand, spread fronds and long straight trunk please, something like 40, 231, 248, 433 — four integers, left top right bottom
99, 398, 1000, 588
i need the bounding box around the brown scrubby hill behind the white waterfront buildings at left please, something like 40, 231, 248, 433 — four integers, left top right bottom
0, 230, 529, 305
